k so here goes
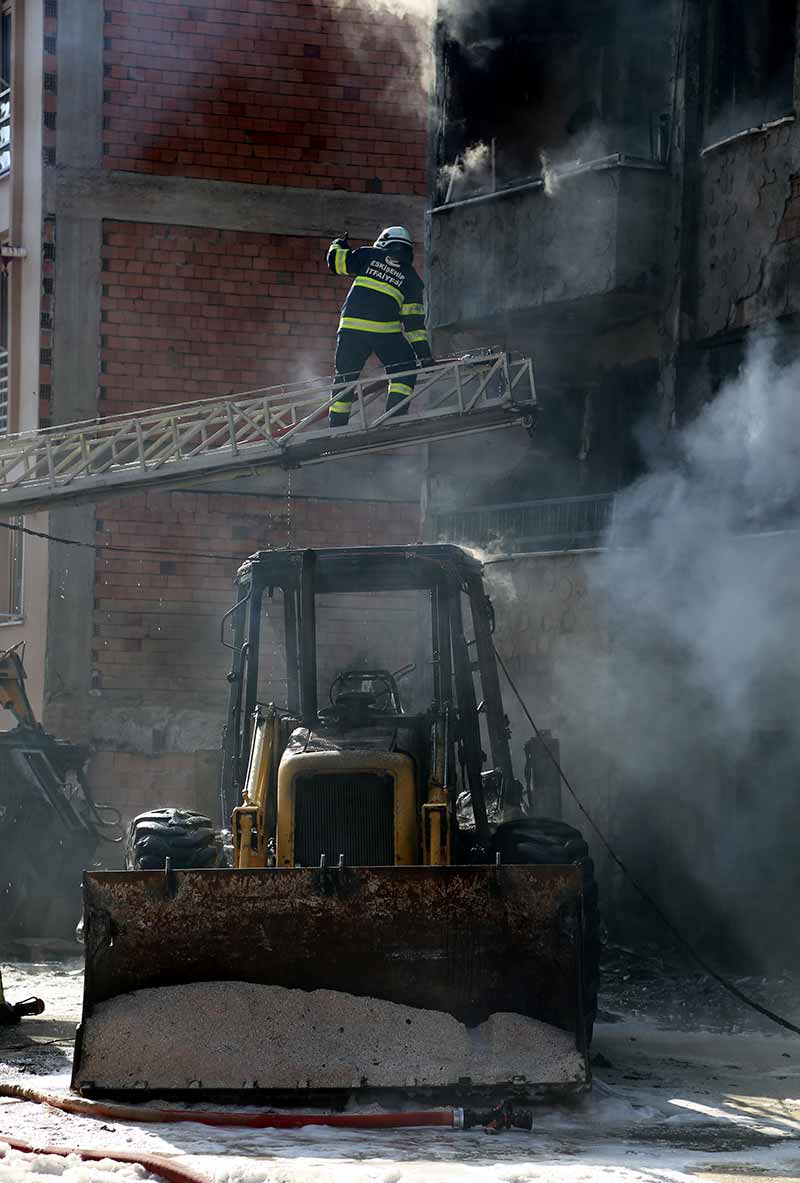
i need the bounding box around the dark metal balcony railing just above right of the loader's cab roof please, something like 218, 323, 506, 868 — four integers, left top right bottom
434, 493, 614, 554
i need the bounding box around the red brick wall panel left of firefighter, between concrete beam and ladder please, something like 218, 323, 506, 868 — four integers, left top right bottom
101, 221, 347, 414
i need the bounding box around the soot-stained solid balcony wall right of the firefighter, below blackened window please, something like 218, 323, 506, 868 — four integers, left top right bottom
428, 154, 666, 331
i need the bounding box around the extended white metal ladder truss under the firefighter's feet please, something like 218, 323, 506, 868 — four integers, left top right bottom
0, 351, 536, 513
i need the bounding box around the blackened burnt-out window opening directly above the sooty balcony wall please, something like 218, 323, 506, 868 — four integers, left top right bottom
438, 0, 675, 202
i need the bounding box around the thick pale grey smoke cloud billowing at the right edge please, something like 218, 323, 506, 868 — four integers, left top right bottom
556, 342, 800, 959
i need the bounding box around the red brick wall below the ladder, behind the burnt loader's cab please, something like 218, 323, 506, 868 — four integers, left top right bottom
90, 492, 419, 819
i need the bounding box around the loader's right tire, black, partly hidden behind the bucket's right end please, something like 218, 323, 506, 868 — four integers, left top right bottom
490, 817, 600, 1047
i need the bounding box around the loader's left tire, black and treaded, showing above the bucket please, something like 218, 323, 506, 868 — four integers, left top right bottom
125, 808, 221, 871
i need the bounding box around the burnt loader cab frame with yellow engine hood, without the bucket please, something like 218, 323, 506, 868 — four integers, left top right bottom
221, 547, 521, 867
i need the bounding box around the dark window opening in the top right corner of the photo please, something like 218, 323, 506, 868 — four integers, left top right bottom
705, 0, 798, 143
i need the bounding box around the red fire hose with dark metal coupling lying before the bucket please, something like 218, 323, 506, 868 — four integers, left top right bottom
0, 1085, 534, 1133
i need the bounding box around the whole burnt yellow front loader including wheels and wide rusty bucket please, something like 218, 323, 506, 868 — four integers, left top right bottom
72, 545, 599, 1104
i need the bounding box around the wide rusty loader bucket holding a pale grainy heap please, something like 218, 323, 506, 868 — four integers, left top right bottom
72, 866, 588, 1104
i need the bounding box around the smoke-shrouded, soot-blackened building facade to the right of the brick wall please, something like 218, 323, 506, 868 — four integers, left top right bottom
428, 0, 800, 964
